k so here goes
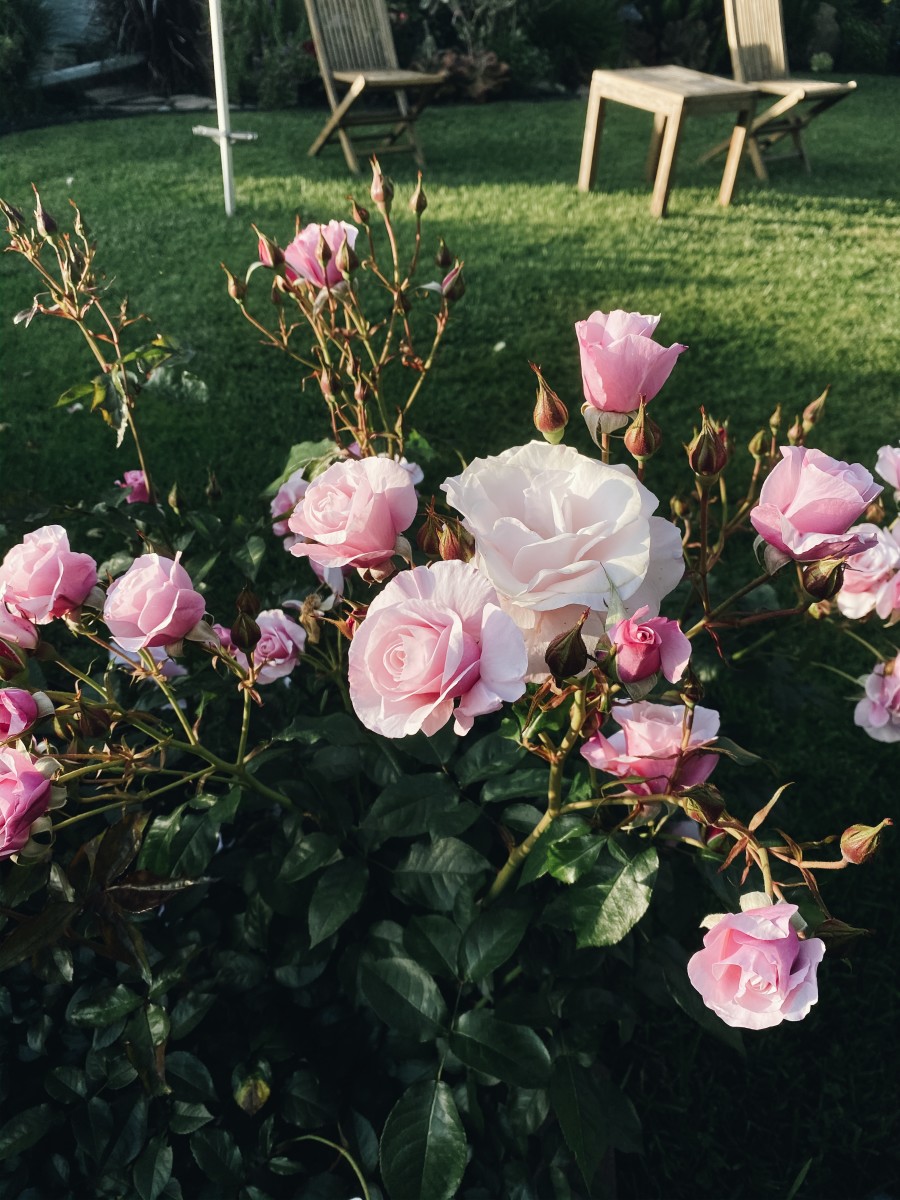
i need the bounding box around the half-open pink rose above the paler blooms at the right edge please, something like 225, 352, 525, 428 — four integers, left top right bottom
750, 446, 882, 570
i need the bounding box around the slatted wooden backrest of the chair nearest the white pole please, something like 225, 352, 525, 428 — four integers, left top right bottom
306, 0, 398, 74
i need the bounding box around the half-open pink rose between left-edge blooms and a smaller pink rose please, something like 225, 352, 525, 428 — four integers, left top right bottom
103, 554, 206, 654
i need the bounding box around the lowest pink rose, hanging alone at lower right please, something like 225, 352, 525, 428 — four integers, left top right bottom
688, 904, 824, 1030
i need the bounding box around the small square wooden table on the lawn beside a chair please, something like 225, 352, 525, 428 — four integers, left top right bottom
578, 66, 756, 217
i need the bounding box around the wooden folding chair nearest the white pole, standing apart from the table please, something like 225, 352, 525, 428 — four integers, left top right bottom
306, 0, 445, 174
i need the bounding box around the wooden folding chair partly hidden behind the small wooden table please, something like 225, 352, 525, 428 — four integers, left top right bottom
701, 0, 856, 179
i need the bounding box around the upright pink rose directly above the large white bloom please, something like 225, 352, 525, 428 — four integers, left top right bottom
575, 308, 688, 438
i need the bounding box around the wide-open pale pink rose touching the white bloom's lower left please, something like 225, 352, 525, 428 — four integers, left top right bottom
349, 559, 527, 738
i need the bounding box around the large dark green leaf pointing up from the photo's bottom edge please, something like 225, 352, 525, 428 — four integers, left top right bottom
380, 1080, 466, 1200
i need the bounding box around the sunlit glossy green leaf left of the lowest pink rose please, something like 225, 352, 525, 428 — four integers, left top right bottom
565, 846, 659, 948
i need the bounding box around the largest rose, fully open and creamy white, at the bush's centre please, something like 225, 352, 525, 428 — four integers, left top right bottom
443, 442, 684, 674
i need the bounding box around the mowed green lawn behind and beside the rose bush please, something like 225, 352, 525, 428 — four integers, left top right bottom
0, 77, 900, 1200
